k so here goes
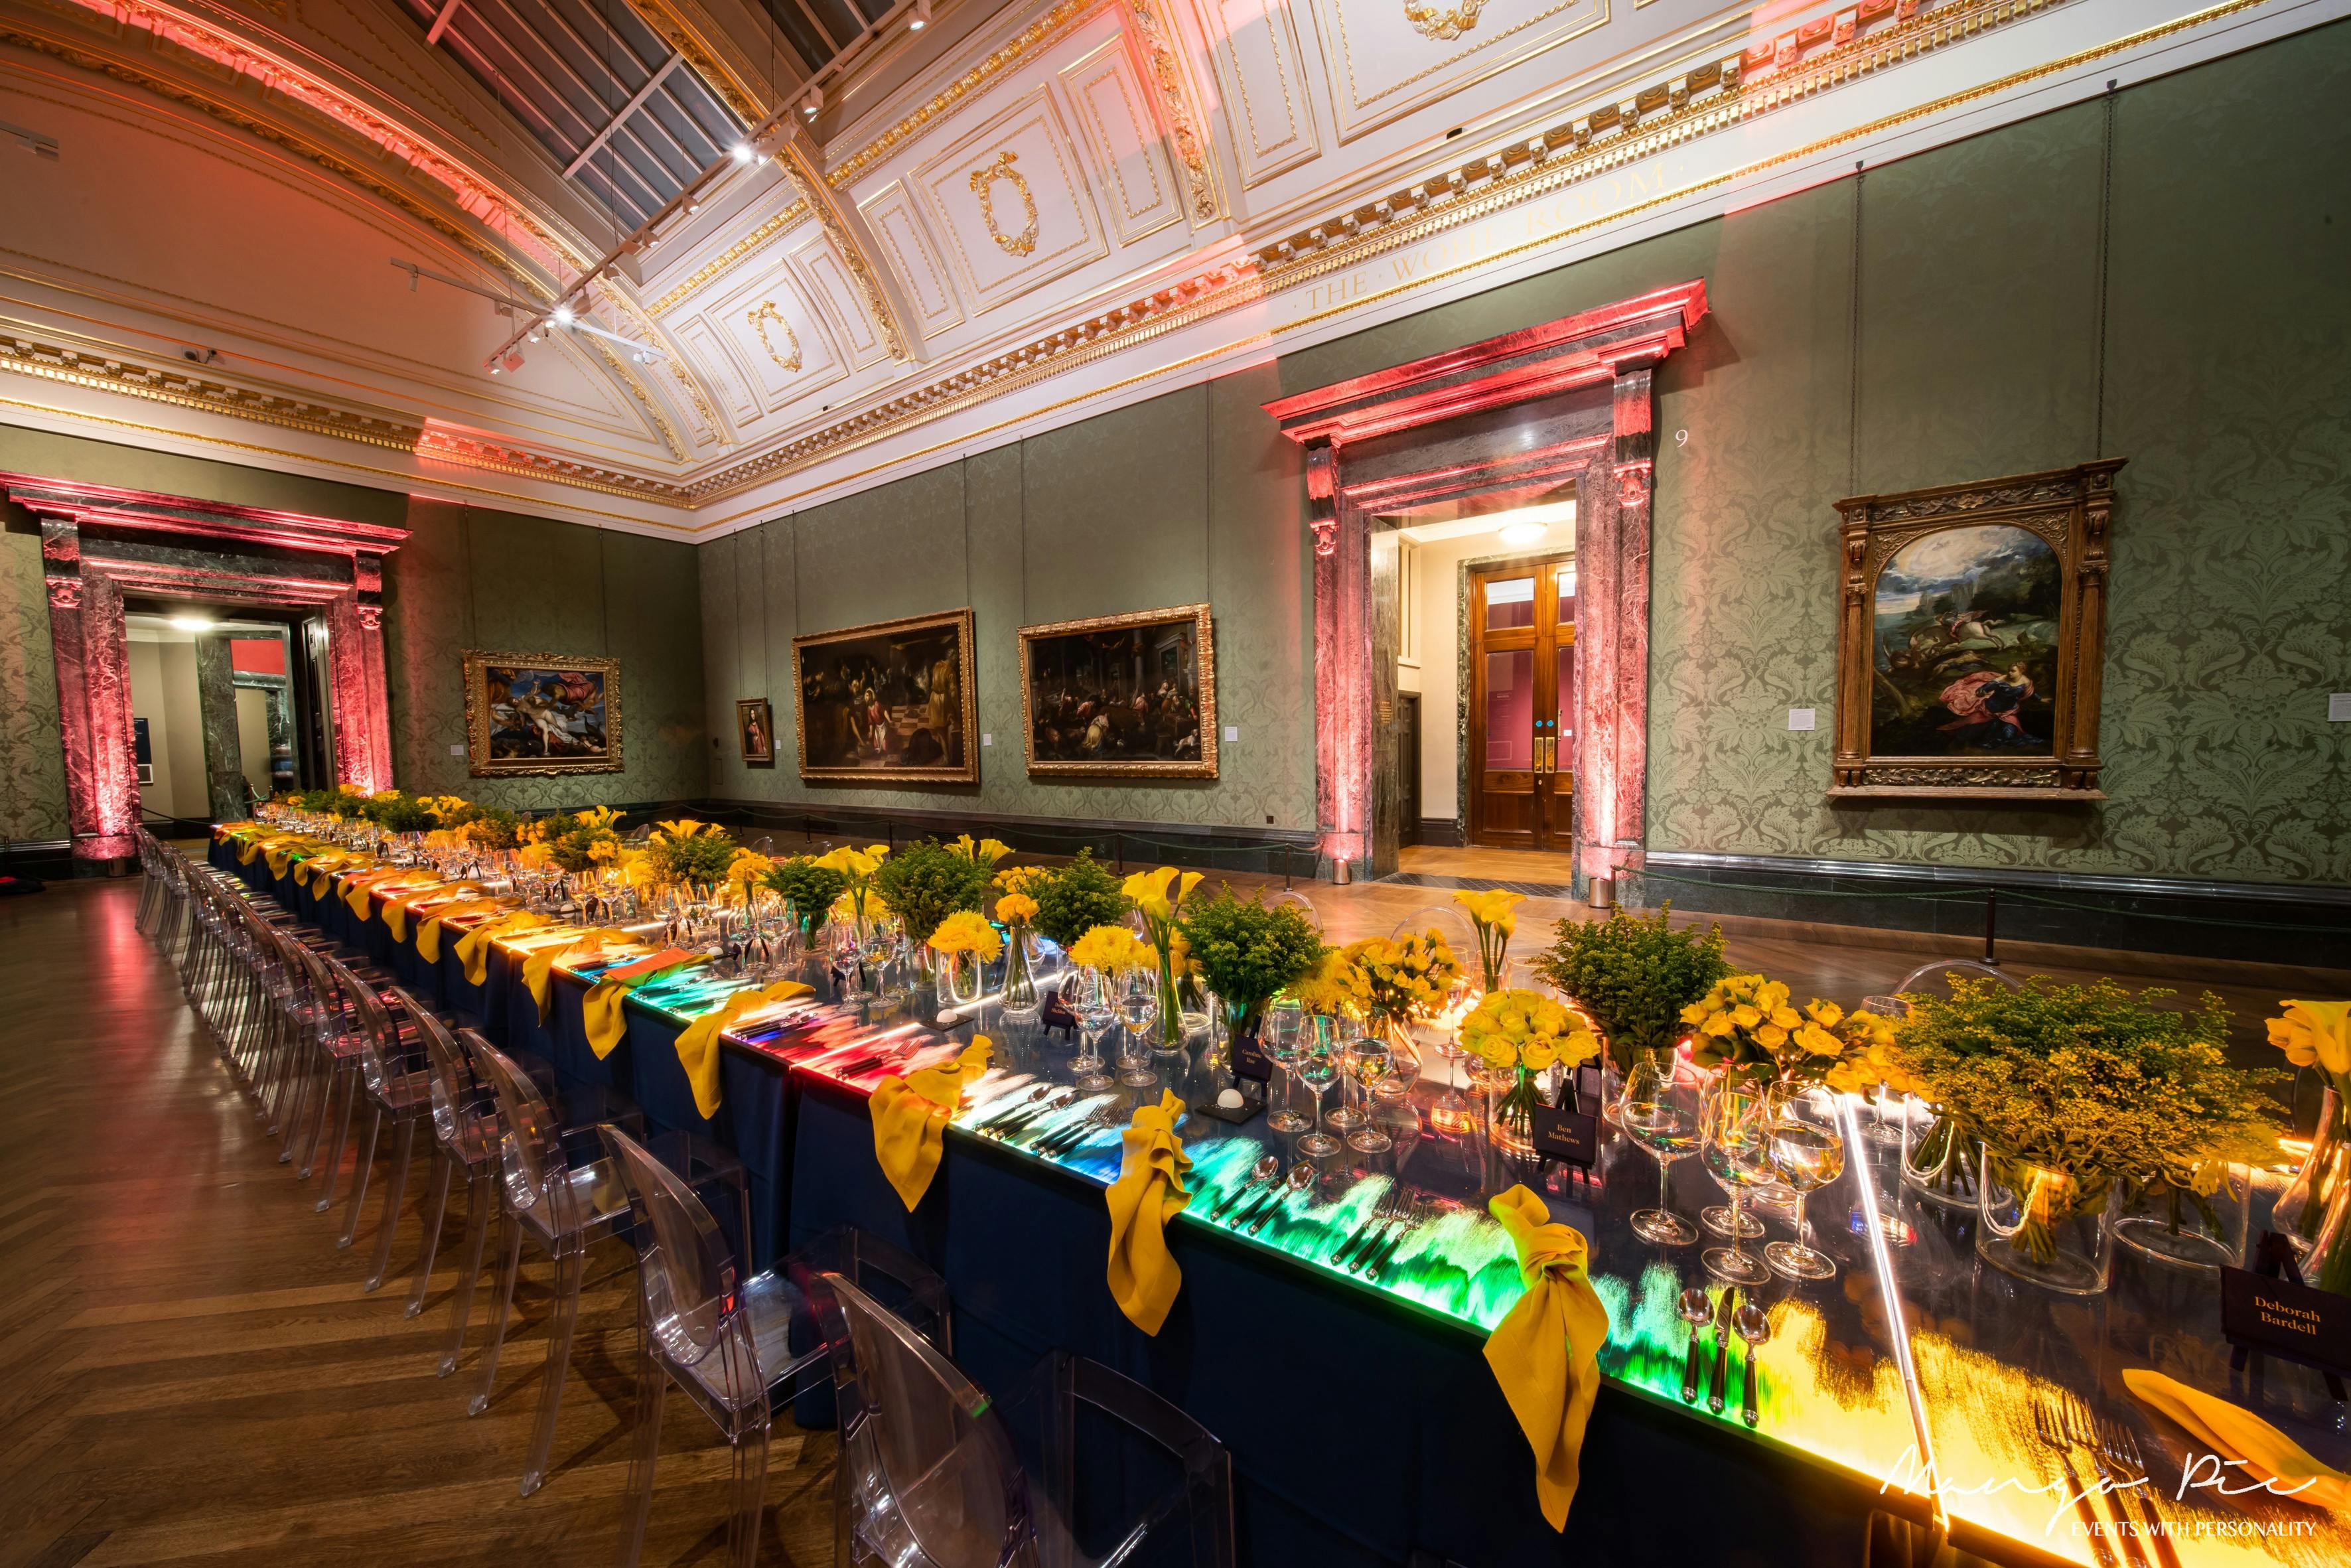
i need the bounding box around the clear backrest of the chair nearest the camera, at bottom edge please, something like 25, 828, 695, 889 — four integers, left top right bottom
821, 1274, 1036, 1568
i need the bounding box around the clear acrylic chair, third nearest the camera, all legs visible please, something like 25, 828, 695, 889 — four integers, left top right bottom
459, 1030, 628, 1498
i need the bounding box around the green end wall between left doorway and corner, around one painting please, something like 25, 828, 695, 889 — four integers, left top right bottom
384, 498, 705, 811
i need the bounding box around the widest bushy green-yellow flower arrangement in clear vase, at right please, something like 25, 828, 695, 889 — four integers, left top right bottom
1892, 975, 2273, 1295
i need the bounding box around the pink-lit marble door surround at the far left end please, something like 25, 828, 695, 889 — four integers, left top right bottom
0, 472, 409, 865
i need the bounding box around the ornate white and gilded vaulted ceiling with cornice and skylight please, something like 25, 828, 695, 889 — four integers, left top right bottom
0, 0, 2344, 534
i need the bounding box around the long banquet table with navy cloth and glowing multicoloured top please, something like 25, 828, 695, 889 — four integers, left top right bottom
212, 827, 2351, 1568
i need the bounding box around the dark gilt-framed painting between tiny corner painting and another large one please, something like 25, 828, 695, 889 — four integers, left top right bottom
792, 609, 980, 783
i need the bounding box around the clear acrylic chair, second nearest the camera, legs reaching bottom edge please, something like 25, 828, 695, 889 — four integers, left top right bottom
597, 1126, 948, 1568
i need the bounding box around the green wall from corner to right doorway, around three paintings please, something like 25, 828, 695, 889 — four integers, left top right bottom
701, 367, 1315, 832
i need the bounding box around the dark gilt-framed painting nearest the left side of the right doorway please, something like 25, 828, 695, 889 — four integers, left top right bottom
1021, 604, 1218, 778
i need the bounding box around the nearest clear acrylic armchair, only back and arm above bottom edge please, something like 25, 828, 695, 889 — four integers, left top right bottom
814, 1277, 1234, 1568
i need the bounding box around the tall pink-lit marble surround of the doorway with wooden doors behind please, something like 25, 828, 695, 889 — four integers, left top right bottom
1265, 280, 1707, 893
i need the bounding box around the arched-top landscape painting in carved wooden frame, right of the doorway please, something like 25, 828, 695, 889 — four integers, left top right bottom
1829, 459, 2125, 802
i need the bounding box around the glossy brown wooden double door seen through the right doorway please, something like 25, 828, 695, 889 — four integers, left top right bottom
1464, 555, 1575, 851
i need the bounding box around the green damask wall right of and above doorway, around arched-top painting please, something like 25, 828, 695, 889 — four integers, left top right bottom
1281, 23, 2351, 884
